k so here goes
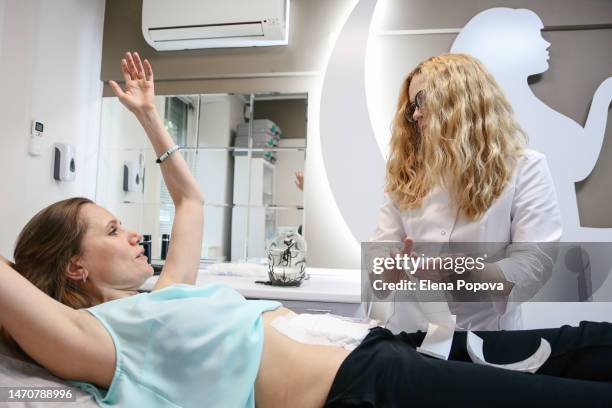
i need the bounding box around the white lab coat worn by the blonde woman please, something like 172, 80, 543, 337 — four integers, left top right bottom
371, 149, 562, 331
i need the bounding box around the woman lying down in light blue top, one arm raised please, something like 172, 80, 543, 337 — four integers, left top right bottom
0, 53, 612, 408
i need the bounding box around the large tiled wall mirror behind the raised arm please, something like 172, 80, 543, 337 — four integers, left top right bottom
96, 93, 308, 262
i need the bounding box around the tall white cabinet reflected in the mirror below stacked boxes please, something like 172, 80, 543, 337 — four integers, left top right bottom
231, 156, 276, 261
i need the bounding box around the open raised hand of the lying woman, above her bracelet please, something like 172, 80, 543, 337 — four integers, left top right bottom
108, 52, 155, 113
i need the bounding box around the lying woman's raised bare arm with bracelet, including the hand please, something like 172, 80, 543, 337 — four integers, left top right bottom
109, 52, 204, 290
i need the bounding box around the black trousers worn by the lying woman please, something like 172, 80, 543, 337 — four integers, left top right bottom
325, 322, 612, 408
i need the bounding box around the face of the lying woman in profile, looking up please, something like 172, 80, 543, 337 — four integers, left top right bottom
80, 204, 153, 290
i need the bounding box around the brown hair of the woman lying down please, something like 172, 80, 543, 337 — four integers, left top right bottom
1, 197, 94, 346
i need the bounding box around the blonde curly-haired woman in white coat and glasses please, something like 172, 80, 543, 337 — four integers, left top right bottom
372, 54, 561, 330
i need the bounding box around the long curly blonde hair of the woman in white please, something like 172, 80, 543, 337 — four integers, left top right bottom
385, 54, 527, 220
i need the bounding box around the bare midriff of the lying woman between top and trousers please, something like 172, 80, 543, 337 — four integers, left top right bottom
255, 307, 349, 408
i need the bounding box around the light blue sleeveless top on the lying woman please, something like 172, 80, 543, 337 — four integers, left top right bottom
70, 283, 281, 408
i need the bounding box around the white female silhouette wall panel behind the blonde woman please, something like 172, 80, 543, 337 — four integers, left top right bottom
450, 8, 612, 241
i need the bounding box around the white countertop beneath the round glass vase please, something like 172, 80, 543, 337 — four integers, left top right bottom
141, 268, 361, 303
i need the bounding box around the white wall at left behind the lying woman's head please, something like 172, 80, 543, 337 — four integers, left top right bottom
0, 0, 104, 258
